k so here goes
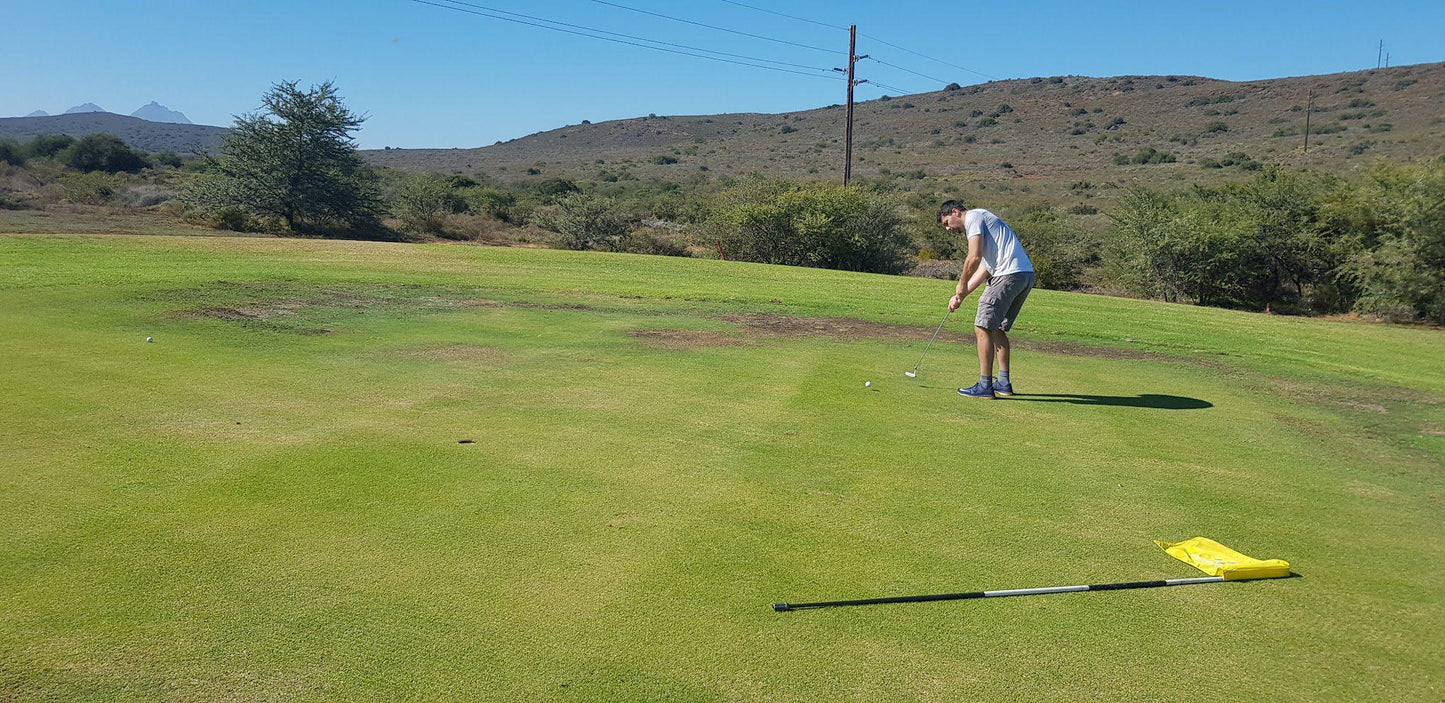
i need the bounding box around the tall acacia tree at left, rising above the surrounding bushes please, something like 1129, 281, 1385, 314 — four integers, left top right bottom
186, 81, 380, 230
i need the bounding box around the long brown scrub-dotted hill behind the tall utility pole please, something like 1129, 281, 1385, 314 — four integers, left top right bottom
367, 64, 1445, 202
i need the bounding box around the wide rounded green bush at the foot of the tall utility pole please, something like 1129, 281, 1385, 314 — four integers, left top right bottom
707, 182, 913, 273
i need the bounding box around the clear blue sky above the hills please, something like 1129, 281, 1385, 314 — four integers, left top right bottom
0, 0, 1445, 149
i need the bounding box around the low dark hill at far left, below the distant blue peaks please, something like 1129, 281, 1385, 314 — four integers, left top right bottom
0, 113, 230, 153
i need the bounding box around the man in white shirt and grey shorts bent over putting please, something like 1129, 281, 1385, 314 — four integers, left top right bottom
938, 201, 1033, 398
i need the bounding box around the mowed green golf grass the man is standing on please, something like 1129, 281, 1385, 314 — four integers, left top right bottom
0, 237, 1445, 700
